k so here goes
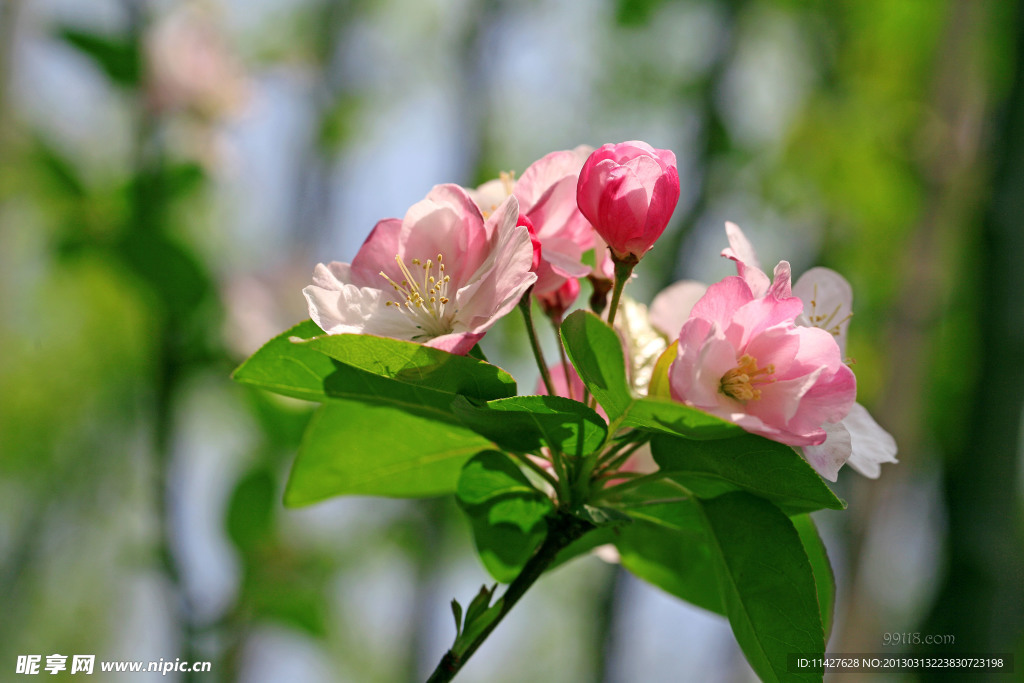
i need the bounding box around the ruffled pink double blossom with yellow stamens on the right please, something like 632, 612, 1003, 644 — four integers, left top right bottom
669, 270, 856, 445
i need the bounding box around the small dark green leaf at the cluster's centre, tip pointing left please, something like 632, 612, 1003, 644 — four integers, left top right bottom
452, 396, 608, 457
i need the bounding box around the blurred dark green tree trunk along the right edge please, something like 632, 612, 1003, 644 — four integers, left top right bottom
922, 3, 1024, 680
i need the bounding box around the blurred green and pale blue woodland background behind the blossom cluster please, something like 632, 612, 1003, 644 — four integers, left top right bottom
0, 0, 1024, 683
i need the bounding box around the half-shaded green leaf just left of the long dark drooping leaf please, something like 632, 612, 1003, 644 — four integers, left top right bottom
615, 490, 725, 614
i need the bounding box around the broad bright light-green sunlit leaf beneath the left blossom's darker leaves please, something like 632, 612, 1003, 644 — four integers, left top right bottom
285, 398, 490, 506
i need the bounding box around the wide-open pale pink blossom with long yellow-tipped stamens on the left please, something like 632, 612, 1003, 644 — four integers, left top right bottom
302, 185, 537, 353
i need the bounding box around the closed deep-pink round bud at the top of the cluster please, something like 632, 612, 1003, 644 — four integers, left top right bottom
577, 141, 679, 262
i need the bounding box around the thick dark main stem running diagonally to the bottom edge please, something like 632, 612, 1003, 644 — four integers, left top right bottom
427, 512, 594, 683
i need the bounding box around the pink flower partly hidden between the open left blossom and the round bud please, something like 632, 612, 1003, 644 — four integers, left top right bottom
469, 145, 594, 295
